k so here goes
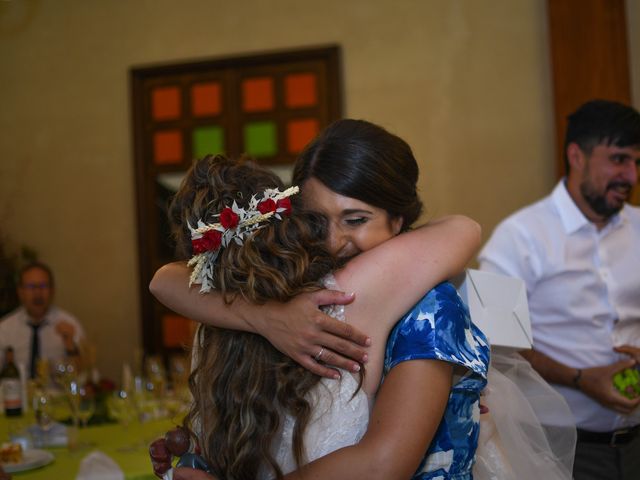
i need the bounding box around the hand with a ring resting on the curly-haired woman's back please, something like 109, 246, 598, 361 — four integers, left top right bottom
251, 290, 370, 378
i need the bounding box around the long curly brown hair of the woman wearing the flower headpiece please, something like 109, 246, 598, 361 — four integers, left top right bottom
170, 156, 335, 480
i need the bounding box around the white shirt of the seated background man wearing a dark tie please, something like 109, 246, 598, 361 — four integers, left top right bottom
0, 306, 84, 371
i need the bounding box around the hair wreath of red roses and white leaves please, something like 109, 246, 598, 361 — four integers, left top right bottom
187, 187, 300, 293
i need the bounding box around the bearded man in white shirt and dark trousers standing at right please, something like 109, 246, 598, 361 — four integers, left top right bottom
478, 100, 640, 480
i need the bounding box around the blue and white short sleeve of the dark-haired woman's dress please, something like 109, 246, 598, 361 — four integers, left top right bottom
385, 282, 489, 379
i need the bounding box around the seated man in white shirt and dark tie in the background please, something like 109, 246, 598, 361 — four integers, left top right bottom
0, 262, 84, 378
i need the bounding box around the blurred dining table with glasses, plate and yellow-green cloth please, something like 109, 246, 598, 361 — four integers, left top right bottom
0, 357, 189, 480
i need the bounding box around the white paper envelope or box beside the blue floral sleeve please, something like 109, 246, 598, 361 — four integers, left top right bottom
453, 269, 533, 350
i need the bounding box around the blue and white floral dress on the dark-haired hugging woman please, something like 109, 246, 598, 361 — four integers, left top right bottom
384, 282, 489, 480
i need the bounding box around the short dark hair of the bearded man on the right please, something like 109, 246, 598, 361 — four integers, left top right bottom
564, 100, 640, 174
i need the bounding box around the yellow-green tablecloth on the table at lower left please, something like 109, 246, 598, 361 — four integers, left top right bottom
0, 416, 176, 480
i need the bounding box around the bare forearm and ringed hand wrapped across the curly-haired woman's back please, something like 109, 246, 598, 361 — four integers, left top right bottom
149, 262, 370, 378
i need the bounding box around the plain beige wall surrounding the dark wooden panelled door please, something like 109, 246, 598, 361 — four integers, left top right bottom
0, 0, 640, 377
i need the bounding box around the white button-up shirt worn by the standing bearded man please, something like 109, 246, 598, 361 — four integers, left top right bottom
478, 181, 640, 431
